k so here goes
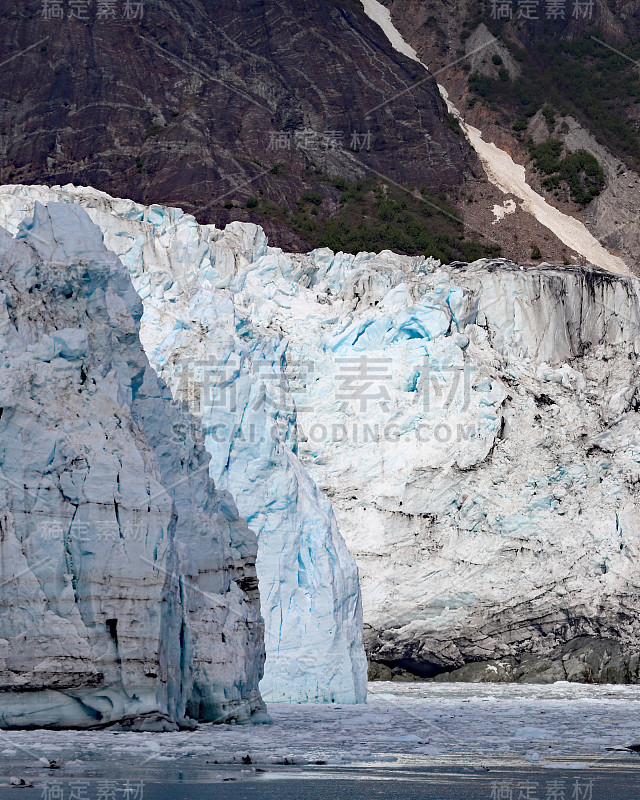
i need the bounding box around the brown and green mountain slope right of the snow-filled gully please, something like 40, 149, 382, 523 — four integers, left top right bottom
384, 0, 640, 273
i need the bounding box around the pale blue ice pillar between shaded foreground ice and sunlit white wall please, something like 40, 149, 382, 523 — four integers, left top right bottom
0, 187, 367, 703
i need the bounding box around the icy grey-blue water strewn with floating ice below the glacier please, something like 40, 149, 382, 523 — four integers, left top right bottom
0, 683, 640, 800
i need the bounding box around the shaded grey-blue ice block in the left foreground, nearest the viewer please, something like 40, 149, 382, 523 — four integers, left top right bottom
0, 204, 264, 730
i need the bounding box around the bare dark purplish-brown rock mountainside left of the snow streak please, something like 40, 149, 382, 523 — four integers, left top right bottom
0, 0, 483, 248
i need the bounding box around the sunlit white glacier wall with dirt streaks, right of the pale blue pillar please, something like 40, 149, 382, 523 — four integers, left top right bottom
284, 253, 640, 681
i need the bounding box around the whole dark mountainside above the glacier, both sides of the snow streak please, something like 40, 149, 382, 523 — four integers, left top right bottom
0, 0, 640, 268
